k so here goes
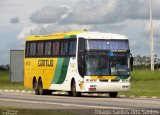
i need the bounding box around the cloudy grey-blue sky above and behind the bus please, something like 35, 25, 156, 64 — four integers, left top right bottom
0, 0, 160, 65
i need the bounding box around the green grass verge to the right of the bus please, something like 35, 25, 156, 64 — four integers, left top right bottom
121, 69, 160, 97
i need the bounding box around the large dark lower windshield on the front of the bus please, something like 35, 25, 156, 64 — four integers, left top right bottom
85, 51, 129, 76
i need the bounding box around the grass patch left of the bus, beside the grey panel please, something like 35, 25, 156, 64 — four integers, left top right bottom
0, 71, 27, 90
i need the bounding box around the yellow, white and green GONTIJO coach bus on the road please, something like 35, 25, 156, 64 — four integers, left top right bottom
24, 31, 132, 97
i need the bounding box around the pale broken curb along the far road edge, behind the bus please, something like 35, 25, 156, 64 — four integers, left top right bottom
0, 89, 160, 99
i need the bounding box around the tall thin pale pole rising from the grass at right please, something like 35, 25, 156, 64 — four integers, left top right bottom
150, 0, 154, 71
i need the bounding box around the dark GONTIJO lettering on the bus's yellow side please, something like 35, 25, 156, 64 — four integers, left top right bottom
38, 60, 53, 67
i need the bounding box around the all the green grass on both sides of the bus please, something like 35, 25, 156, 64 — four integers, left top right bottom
0, 70, 160, 97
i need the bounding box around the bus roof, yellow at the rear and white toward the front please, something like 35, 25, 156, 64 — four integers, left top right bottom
27, 31, 128, 41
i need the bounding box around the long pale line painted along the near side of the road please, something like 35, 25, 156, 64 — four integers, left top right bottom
0, 98, 125, 109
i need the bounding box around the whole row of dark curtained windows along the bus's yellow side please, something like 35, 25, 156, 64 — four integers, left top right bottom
26, 39, 76, 57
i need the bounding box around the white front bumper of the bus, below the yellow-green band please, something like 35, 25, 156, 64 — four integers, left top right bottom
83, 82, 130, 92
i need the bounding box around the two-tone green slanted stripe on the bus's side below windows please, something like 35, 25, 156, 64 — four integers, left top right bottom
52, 58, 70, 84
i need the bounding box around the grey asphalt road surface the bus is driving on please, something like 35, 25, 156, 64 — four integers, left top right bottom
0, 92, 160, 109
